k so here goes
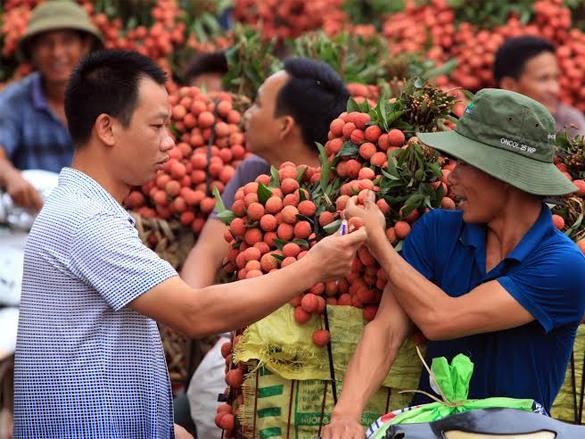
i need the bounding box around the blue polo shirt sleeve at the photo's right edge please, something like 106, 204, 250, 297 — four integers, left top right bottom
497, 246, 585, 332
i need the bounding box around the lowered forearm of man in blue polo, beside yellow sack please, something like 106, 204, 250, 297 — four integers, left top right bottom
333, 321, 401, 421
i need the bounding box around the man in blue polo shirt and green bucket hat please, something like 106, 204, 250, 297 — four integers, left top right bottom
322, 89, 585, 439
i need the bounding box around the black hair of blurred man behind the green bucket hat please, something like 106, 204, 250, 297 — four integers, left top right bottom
494, 35, 555, 85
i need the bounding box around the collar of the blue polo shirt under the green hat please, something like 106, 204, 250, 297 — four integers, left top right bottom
460, 204, 554, 262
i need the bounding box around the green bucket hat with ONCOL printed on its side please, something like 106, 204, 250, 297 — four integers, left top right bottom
417, 88, 577, 196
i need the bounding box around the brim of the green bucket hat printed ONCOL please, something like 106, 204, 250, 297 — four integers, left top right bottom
416, 131, 577, 196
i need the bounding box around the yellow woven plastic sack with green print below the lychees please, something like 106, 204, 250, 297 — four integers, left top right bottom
234, 305, 421, 439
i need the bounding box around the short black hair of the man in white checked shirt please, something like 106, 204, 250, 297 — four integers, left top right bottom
65, 50, 167, 148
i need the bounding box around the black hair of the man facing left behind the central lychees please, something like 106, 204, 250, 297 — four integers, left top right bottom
274, 57, 349, 148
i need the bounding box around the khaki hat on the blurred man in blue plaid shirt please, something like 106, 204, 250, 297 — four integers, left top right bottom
18, 0, 103, 60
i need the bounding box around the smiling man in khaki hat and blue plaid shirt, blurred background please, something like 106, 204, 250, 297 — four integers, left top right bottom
0, 0, 102, 209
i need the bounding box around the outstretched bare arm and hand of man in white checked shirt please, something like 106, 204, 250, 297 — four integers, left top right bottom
135, 230, 367, 337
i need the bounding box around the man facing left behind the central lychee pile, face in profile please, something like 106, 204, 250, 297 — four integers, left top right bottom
175, 58, 349, 439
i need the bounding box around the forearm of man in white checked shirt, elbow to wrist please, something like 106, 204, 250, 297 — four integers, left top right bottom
187, 258, 320, 336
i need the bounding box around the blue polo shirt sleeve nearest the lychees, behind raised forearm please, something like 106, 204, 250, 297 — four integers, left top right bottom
401, 212, 437, 280
